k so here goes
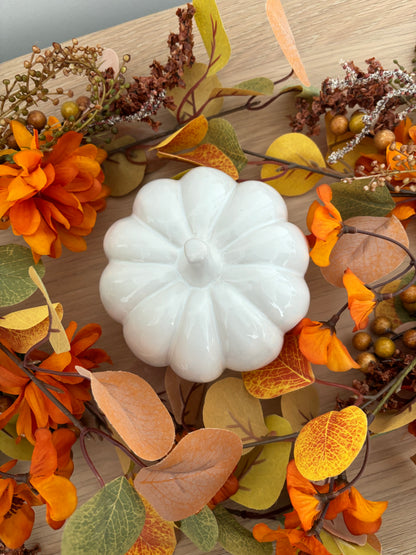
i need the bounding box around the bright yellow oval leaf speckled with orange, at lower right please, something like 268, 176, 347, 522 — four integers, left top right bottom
294, 405, 367, 481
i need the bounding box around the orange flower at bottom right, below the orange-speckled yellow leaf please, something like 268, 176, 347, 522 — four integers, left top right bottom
285, 460, 387, 536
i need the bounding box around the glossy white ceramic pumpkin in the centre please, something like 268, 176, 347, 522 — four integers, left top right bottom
100, 167, 309, 382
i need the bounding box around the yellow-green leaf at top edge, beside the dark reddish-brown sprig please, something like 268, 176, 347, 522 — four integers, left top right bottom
193, 0, 231, 75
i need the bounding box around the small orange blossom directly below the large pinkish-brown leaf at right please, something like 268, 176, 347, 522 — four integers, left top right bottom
342, 268, 377, 331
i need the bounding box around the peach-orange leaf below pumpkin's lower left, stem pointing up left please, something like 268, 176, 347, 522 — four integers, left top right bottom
76, 366, 175, 461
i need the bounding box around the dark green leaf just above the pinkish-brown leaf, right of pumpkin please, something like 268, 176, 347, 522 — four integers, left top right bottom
330, 178, 395, 220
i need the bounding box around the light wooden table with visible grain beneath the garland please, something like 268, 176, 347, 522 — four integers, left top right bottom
0, 0, 416, 555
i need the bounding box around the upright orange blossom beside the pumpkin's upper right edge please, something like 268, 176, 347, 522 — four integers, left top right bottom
308, 185, 343, 266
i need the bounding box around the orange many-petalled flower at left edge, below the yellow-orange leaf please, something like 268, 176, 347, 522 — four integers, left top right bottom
0, 322, 111, 444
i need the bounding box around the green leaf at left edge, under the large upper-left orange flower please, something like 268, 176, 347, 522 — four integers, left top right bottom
0, 245, 45, 306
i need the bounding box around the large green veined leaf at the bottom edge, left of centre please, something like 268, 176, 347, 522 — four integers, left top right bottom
61, 476, 146, 555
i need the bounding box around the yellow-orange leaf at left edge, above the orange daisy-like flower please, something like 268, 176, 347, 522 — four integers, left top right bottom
0, 303, 63, 353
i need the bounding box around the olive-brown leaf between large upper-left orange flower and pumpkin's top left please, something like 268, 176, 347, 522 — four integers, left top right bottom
102, 135, 146, 197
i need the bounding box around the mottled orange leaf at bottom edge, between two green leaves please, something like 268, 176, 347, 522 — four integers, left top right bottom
126, 497, 176, 555
